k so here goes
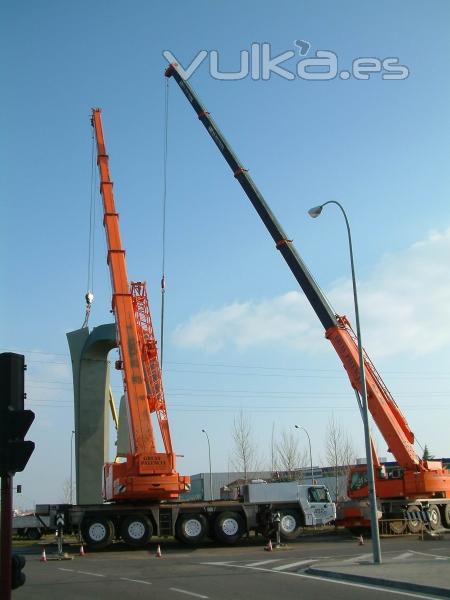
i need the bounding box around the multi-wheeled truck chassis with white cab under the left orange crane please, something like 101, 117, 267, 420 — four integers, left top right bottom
36, 482, 336, 549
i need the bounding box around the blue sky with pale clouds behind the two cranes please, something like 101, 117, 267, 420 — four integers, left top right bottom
0, 0, 450, 506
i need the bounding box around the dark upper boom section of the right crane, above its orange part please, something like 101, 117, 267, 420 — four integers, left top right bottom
165, 65, 337, 329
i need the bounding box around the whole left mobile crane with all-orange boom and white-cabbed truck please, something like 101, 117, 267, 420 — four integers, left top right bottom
36, 109, 336, 549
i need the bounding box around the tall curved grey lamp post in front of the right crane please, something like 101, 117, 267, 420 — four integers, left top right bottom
308, 200, 381, 563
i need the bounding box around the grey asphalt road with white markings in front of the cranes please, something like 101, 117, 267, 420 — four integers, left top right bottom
9, 536, 450, 600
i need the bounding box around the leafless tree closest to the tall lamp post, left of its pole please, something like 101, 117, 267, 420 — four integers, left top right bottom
325, 415, 356, 502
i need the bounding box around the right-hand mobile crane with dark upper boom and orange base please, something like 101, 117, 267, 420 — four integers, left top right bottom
165, 64, 450, 528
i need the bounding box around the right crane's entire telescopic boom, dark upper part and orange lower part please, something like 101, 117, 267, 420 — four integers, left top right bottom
165, 64, 450, 497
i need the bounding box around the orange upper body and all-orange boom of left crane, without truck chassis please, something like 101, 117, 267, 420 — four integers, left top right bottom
92, 108, 190, 501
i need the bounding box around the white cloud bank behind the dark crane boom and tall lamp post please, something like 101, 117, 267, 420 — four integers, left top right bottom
174, 228, 450, 356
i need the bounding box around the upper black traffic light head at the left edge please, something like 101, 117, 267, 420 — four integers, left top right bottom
0, 352, 34, 476
